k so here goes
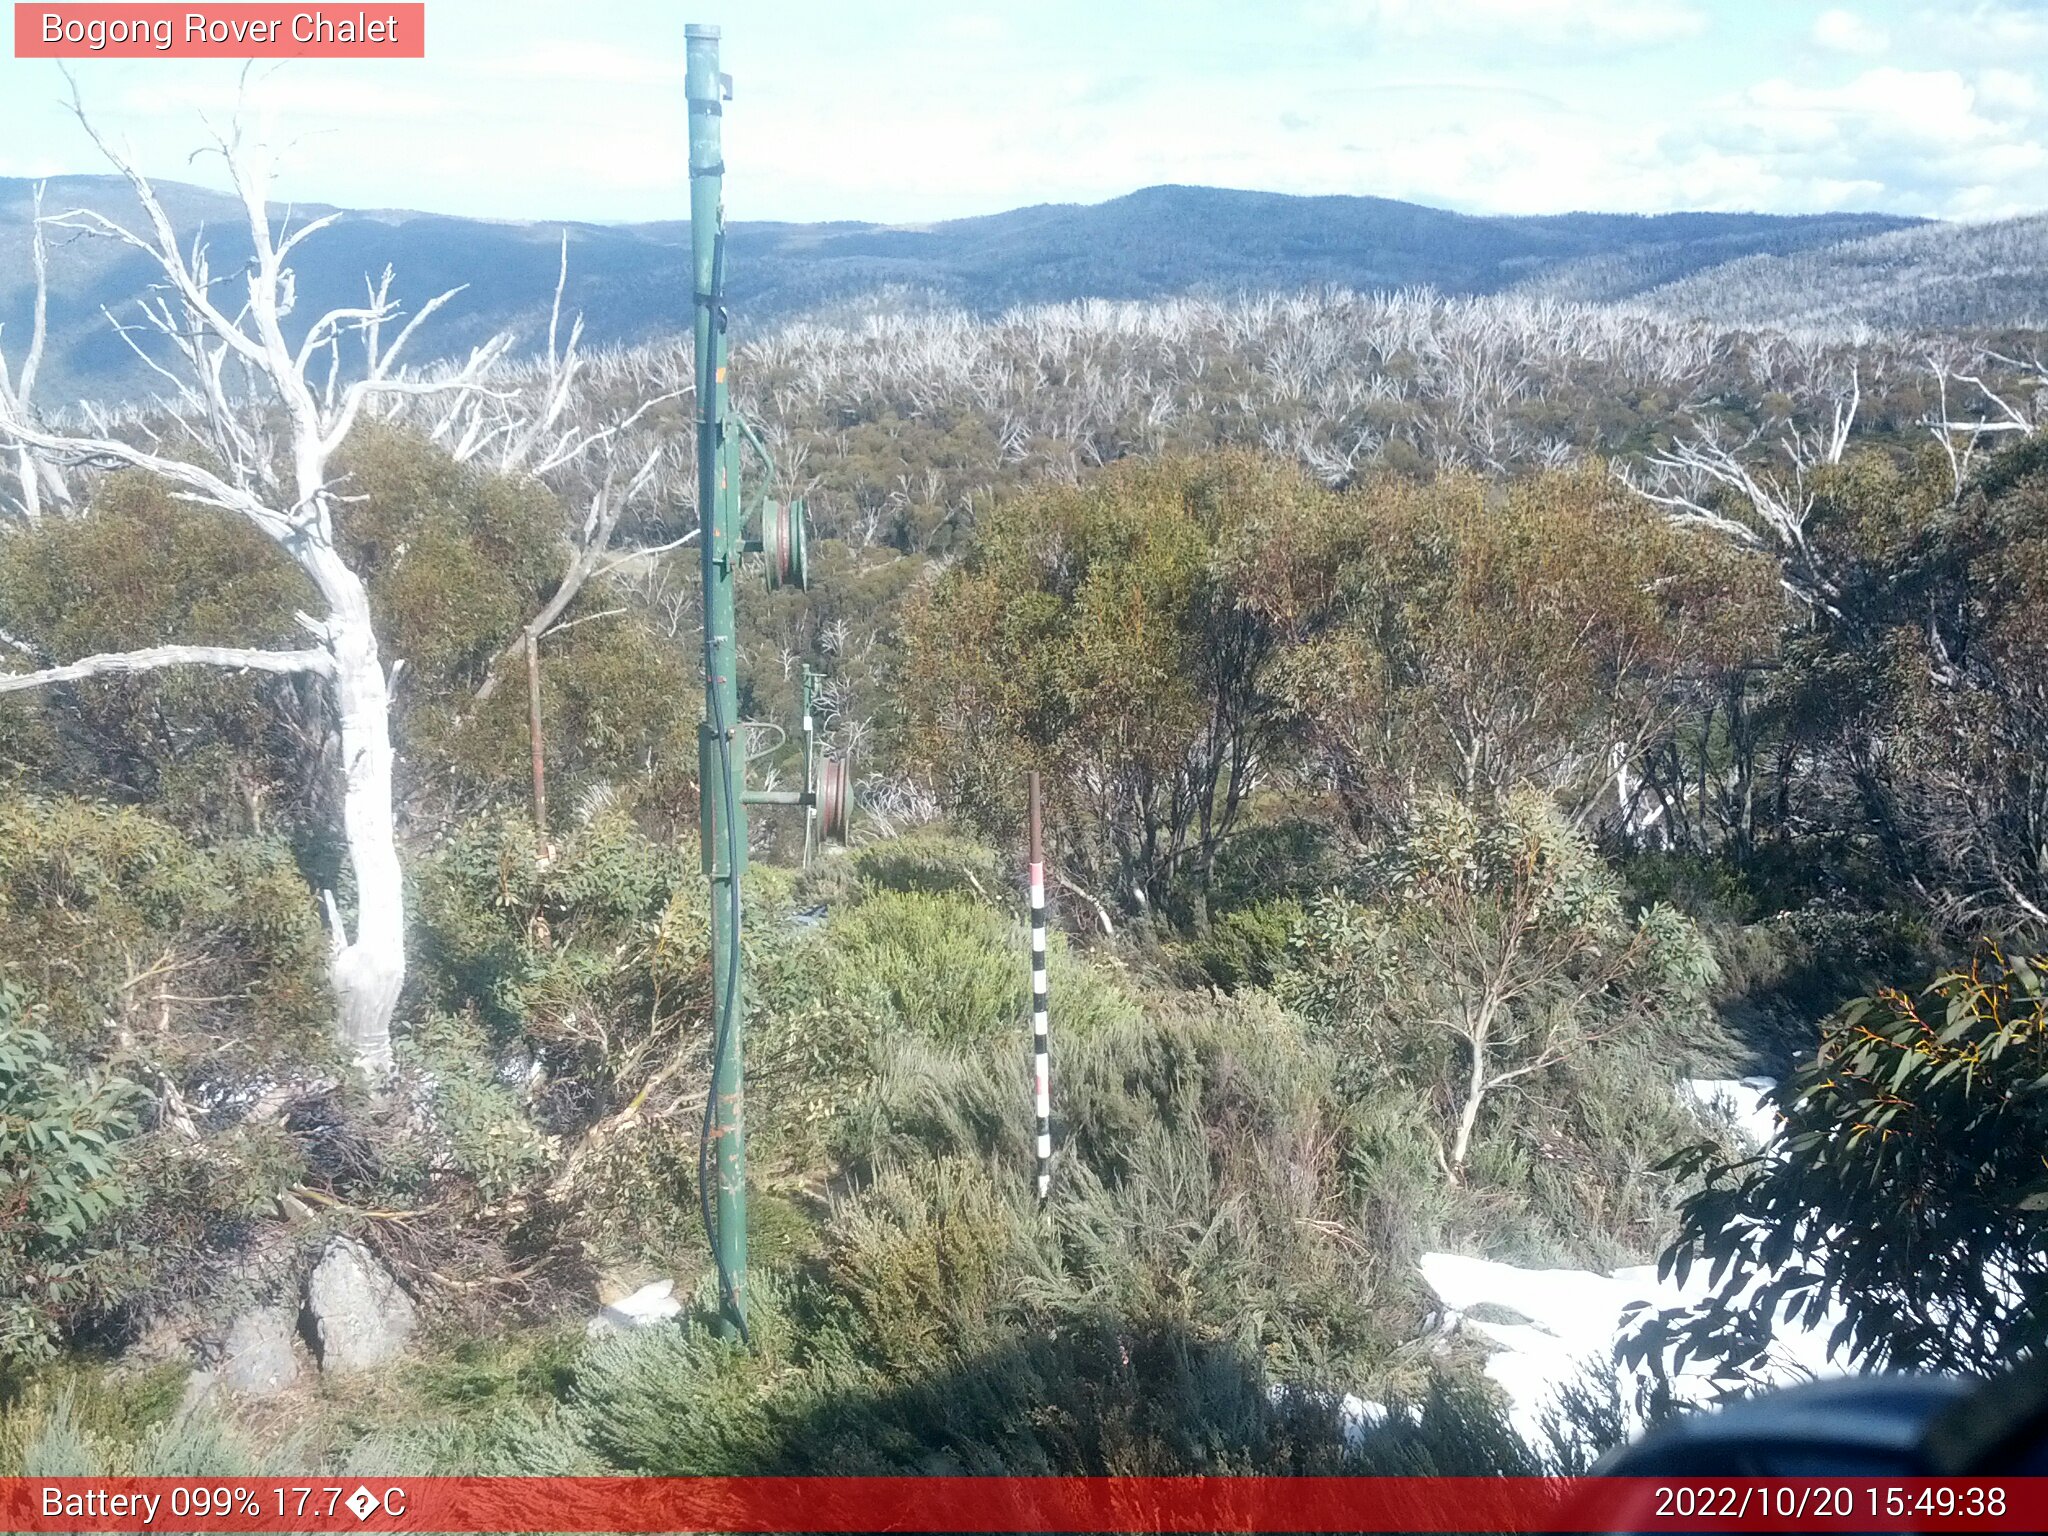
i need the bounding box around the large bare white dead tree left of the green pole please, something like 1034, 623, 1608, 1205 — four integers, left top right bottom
0, 105, 506, 1079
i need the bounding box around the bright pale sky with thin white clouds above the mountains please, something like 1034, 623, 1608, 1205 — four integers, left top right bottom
0, 0, 2048, 223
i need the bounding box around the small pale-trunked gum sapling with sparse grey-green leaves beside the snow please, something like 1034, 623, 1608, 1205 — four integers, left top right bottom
1276, 793, 1714, 1257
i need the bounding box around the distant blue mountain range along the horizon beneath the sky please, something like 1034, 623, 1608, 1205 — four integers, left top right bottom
0, 176, 2048, 406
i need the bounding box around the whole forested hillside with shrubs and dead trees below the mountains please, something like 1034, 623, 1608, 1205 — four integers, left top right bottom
0, 150, 2048, 1475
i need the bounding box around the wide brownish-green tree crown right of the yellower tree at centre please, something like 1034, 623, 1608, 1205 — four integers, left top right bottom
1233, 467, 1782, 843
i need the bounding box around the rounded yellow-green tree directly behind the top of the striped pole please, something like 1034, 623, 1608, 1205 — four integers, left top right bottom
901, 453, 1327, 926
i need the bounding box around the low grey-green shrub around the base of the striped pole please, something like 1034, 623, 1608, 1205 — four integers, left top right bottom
834, 981, 1419, 1384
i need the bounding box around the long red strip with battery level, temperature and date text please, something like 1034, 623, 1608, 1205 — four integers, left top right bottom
0, 1477, 2048, 1532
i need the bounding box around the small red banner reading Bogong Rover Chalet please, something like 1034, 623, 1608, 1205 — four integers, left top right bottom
14, 2, 426, 59
